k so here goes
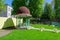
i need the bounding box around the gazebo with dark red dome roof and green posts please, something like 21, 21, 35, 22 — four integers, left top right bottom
15, 6, 31, 28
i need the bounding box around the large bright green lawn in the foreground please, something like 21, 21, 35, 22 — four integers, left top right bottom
0, 30, 60, 40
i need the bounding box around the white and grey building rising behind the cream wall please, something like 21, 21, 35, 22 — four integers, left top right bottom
0, 4, 13, 17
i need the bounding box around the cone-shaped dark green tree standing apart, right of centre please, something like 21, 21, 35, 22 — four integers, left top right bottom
41, 3, 54, 21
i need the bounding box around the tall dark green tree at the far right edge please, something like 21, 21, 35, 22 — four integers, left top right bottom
54, 0, 60, 21
